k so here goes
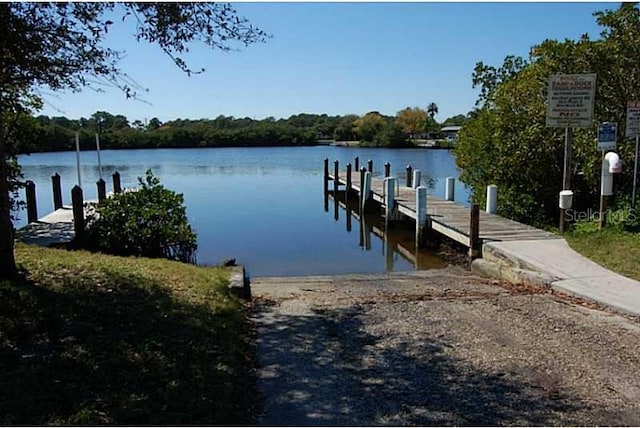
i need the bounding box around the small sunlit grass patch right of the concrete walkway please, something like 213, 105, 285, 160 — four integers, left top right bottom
564, 222, 640, 281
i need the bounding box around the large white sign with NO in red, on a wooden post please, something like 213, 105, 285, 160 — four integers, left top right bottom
547, 74, 596, 128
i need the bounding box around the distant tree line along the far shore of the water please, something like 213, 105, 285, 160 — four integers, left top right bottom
18, 107, 467, 153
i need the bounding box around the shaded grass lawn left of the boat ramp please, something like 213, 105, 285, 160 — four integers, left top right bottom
0, 245, 255, 425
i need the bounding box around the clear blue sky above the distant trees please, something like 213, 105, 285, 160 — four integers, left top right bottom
40, 3, 618, 122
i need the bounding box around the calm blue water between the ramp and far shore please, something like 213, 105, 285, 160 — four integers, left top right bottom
16, 146, 468, 276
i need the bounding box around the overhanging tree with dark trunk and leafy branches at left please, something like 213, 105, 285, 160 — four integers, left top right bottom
0, 2, 267, 278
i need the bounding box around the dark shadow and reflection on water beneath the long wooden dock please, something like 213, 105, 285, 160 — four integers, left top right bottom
324, 190, 447, 272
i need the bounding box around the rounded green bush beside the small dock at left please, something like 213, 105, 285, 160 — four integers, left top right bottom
85, 170, 197, 262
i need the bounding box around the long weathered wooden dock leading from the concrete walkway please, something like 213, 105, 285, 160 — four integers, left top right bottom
325, 160, 560, 256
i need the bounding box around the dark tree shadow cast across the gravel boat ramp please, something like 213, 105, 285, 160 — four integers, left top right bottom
256, 303, 590, 426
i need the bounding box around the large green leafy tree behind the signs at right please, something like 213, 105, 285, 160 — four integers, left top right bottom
455, 3, 640, 226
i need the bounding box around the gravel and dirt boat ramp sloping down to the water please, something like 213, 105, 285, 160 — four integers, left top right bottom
252, 268, 640, 426
